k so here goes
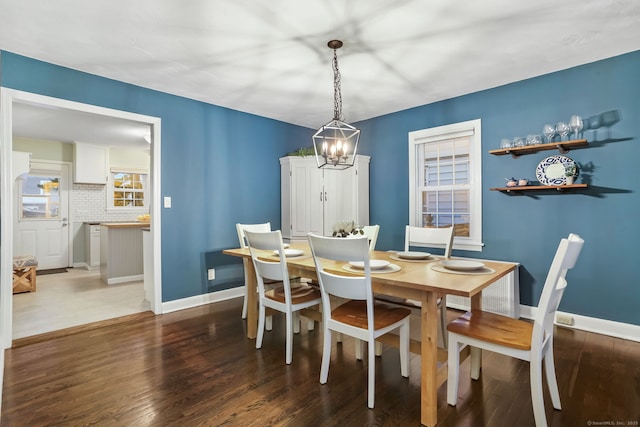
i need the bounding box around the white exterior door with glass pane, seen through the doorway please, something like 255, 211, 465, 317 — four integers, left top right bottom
13, 161, 70, 270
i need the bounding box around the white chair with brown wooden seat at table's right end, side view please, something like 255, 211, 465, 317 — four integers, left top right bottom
447, 234, 584, 427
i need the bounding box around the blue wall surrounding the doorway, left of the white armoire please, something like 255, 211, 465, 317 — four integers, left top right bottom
0, 51, 312, 301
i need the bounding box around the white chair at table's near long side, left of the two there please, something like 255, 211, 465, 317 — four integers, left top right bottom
245, 230, 321, 365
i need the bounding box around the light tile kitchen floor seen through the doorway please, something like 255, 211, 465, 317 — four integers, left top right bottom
13, 268, 149, 339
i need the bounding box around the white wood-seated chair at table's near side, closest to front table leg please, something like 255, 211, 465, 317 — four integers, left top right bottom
308, 234, 411, 408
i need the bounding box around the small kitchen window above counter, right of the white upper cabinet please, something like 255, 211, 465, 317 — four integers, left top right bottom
109, 170, 147, 210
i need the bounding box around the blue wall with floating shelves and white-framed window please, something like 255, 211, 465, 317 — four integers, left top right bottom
357, 51, 640, 325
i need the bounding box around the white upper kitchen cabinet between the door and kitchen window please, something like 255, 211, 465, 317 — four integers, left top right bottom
73, 142, 109, 184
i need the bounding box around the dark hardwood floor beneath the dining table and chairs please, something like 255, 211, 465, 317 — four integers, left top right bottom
0, 299, 640, 426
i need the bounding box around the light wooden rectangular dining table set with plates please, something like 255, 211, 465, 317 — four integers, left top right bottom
223, 241, 518, 426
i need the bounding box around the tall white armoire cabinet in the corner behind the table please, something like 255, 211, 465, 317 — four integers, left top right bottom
280, 156, 370, 240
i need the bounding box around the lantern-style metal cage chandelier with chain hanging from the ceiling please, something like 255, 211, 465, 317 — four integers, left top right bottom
313, 40, 360, 169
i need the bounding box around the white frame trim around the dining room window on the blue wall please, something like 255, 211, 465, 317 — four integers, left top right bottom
409, 119, 484, 252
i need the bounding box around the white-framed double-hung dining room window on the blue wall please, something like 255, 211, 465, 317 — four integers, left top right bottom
409, 120, 482, 251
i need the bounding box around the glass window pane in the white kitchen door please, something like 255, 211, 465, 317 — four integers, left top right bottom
20, 174, 60, 220
